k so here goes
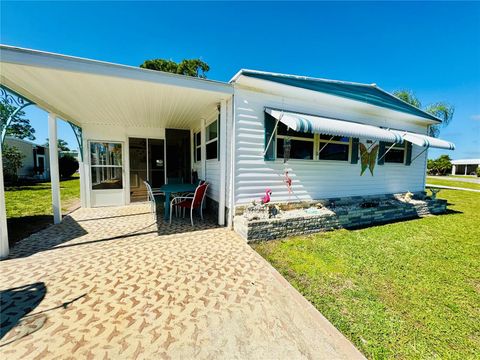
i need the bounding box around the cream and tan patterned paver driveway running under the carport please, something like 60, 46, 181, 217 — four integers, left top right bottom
0, 204, 362, 359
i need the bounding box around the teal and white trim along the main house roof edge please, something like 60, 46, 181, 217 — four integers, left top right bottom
230, 69, 442, 123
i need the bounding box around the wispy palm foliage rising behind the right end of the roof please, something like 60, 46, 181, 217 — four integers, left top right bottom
393, 90, 455, 137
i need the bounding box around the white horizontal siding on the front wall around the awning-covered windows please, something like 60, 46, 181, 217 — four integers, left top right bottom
234, 88, 427, 205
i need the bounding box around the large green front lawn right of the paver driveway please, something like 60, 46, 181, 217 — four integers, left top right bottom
253, 190, 480, 359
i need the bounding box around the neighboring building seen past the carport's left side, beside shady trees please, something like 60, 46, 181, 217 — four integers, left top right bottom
5, 136, 50, 180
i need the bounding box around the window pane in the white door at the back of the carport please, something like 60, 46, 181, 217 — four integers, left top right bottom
90, 142, 123, 190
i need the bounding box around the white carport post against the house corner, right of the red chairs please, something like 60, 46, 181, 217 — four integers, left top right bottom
218, 100, 228, 226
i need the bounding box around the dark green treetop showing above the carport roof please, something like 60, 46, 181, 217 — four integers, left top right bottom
140, 59, 210, 79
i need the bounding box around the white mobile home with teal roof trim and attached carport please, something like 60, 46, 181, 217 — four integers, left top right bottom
1, 46, 454, 224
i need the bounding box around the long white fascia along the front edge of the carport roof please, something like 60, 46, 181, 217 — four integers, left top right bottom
0, 44, 233, 95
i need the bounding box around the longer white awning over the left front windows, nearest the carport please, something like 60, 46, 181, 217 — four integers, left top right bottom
265, 108, 403, 143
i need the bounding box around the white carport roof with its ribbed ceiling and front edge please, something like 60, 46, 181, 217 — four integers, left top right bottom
0, 45, 233, 129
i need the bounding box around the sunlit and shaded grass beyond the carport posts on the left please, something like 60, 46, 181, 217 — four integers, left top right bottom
5, 176, 80, 245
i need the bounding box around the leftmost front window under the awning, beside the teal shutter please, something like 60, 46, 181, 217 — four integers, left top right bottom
277, 122, 315, 160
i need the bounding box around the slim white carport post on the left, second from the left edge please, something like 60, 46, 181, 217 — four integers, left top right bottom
48, 113, 62, 224
